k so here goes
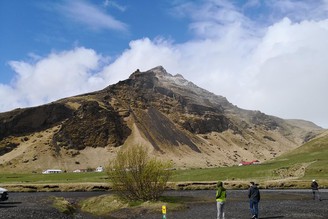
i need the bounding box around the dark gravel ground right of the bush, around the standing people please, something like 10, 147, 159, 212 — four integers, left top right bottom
135, 190, 328, 219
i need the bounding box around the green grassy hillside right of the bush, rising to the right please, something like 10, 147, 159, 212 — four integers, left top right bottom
173, 132, 328, 181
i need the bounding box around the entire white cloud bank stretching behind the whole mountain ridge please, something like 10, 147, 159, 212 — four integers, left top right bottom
0, 0, 328, 127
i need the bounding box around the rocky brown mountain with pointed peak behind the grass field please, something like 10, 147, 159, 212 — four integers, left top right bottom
0, 66, 323, 172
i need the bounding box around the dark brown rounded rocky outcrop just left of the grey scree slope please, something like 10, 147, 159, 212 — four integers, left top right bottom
53, 101, 131, 150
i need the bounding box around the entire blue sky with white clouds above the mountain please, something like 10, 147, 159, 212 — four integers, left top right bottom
0, 0, 328, 128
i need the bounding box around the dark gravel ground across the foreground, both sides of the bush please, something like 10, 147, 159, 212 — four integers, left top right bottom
0, 190, 328, 219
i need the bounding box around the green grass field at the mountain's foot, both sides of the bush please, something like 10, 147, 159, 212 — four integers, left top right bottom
0, 132, 328, 184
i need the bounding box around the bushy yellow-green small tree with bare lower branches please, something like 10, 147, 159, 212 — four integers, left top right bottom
107, 145, 172, 201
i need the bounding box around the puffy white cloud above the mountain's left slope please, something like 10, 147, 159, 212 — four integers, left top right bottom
0, 47, 106, 110
